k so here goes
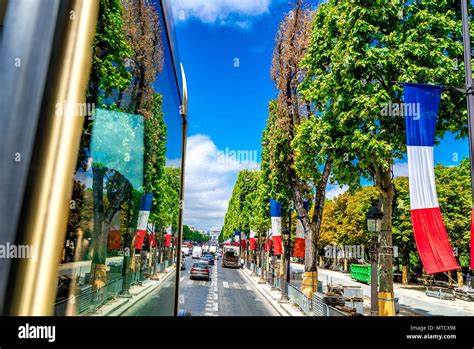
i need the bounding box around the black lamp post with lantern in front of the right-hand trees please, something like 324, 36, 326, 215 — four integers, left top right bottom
365, 201, 383, 316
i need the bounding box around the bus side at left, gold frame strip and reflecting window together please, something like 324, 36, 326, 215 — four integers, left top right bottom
0, 0, 186, 316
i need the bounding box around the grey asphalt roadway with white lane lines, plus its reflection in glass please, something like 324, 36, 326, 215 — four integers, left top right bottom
123, 257, 279, 316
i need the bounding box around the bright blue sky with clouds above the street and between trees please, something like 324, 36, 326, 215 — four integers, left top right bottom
172, 0, 468, 229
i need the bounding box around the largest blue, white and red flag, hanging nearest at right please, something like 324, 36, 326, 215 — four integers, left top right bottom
402, 83, 459, 274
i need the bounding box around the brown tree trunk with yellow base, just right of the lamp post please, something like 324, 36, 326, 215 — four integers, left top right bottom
376, 168, 395, 316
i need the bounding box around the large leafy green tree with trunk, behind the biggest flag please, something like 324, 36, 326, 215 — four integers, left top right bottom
300, 0, 466, 304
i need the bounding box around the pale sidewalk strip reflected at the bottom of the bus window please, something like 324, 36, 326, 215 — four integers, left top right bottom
88, 266, 176, 316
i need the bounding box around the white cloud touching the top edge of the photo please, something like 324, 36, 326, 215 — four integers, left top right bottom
172, 0, 271, 25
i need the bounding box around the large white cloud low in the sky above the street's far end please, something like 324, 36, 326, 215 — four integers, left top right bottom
179, 134, 259, 230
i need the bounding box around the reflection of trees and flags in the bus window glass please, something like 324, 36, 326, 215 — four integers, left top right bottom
55, 0, 182, 316
